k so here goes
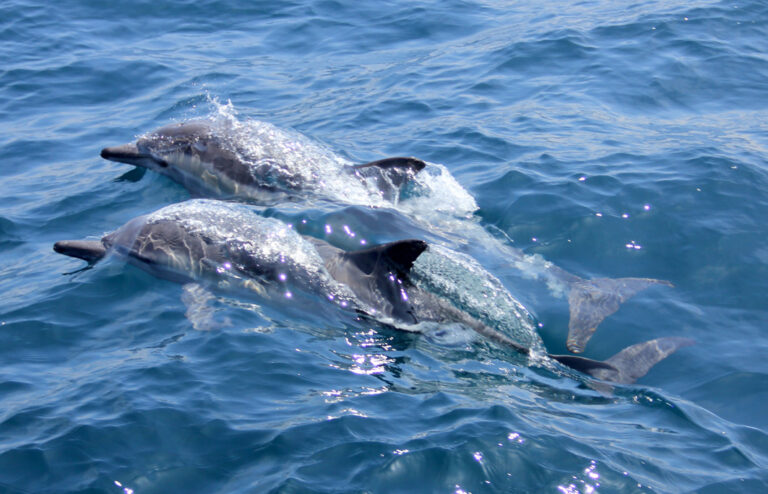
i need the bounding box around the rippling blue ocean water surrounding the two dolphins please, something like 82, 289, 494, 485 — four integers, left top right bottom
0, 0, 768, 494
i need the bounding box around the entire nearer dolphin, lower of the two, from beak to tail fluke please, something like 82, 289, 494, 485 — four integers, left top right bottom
54, 200, 689, 383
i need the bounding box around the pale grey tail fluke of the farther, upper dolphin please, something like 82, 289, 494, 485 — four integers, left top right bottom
566, 278, 672, 353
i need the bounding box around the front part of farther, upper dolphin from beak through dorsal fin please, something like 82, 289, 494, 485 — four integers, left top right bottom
101, 120, 426, 204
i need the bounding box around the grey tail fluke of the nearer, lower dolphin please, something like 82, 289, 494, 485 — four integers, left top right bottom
549, 337, 694, 384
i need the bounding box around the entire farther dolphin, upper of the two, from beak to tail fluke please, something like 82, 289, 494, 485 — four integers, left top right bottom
101, 117, 672, 353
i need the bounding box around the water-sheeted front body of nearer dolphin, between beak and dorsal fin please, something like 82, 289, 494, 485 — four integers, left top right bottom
94, 199, 352, 301
